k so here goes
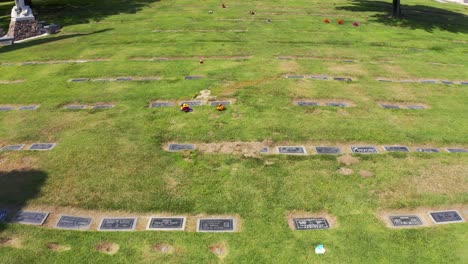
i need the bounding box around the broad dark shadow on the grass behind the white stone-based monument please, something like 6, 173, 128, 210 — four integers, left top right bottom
0, 0, 160, 28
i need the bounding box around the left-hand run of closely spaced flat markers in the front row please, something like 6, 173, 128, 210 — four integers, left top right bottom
0, 209, 237, 232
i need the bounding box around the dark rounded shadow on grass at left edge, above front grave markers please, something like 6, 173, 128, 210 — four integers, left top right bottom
0, 170, 47, 232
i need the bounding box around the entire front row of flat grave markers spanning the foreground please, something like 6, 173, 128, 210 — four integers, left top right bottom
0, 209, 464, 232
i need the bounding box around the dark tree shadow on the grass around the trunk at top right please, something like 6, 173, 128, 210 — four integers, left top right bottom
336, 0, 468, 33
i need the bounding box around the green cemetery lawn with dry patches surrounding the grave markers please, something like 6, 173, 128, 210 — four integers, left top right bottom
0, 0, 468, 263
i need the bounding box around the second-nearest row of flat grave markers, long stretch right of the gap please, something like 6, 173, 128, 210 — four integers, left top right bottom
168, 143, 468, 155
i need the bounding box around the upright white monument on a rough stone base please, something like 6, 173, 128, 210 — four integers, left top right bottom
7, 0, 44, 41
